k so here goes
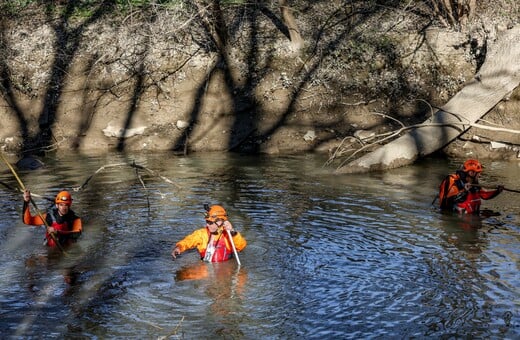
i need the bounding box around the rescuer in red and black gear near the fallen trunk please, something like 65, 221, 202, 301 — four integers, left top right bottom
438, 159, 504, 214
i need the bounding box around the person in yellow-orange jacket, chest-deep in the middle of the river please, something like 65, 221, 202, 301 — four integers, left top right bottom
172, 205, 247, 262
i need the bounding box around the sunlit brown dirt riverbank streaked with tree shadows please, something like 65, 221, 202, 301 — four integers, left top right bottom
0, 5, 520, 166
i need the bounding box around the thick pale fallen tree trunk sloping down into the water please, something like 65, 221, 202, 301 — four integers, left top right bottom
336, 26, 520, 173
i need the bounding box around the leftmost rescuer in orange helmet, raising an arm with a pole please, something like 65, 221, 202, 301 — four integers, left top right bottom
22, 190, 83, 247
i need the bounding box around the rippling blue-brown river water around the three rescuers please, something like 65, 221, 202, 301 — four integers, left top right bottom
0, 153, 520, 339
